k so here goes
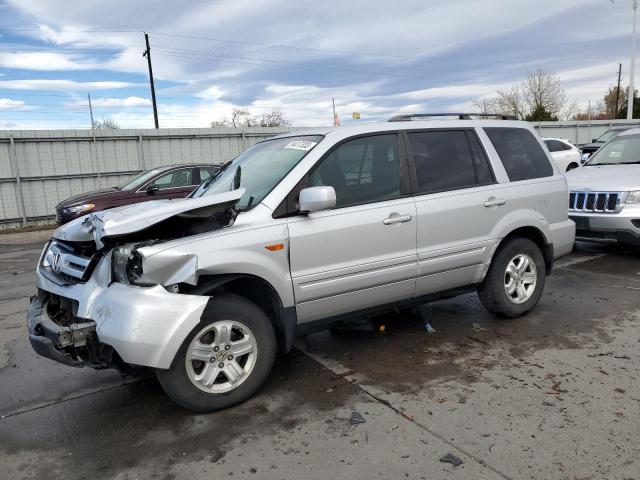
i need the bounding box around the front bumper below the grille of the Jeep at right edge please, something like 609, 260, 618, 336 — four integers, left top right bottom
569, 205, 640, 246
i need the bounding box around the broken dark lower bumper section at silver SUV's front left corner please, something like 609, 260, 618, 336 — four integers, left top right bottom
27, 291, 118, 369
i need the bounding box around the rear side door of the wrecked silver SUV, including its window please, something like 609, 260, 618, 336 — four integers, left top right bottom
406, 128, 509, 296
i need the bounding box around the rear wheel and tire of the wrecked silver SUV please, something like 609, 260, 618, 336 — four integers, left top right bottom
477, 237, 546, 318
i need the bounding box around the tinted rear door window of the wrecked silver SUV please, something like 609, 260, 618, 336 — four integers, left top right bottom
408, 130, 492, 193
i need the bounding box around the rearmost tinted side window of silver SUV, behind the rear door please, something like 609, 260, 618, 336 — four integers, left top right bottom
484, 128, 553, 182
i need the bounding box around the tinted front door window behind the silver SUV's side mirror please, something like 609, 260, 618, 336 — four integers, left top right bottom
308, 134, 400, 208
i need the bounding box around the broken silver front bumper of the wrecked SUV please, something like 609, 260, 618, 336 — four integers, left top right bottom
27, 255, 209, 368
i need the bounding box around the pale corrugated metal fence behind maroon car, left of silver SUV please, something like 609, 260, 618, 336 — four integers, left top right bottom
0, 127, 291, 230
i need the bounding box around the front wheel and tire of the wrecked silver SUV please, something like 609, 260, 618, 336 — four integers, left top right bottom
156, 294, 276, 413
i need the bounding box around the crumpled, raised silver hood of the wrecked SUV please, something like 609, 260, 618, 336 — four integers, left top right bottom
53, 188, 245, 249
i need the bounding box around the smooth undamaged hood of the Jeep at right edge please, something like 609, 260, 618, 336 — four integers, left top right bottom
567, 164, 640, 192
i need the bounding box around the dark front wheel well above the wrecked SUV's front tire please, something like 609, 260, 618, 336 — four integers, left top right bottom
191, 274, 296, 352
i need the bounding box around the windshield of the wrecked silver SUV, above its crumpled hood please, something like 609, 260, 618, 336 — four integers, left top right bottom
191, 135, 322, 210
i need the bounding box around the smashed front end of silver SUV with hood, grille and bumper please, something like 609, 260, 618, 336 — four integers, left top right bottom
27, 190, 243, 372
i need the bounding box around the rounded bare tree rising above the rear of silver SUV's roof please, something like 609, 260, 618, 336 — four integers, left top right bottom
520, 69, 567, 117
